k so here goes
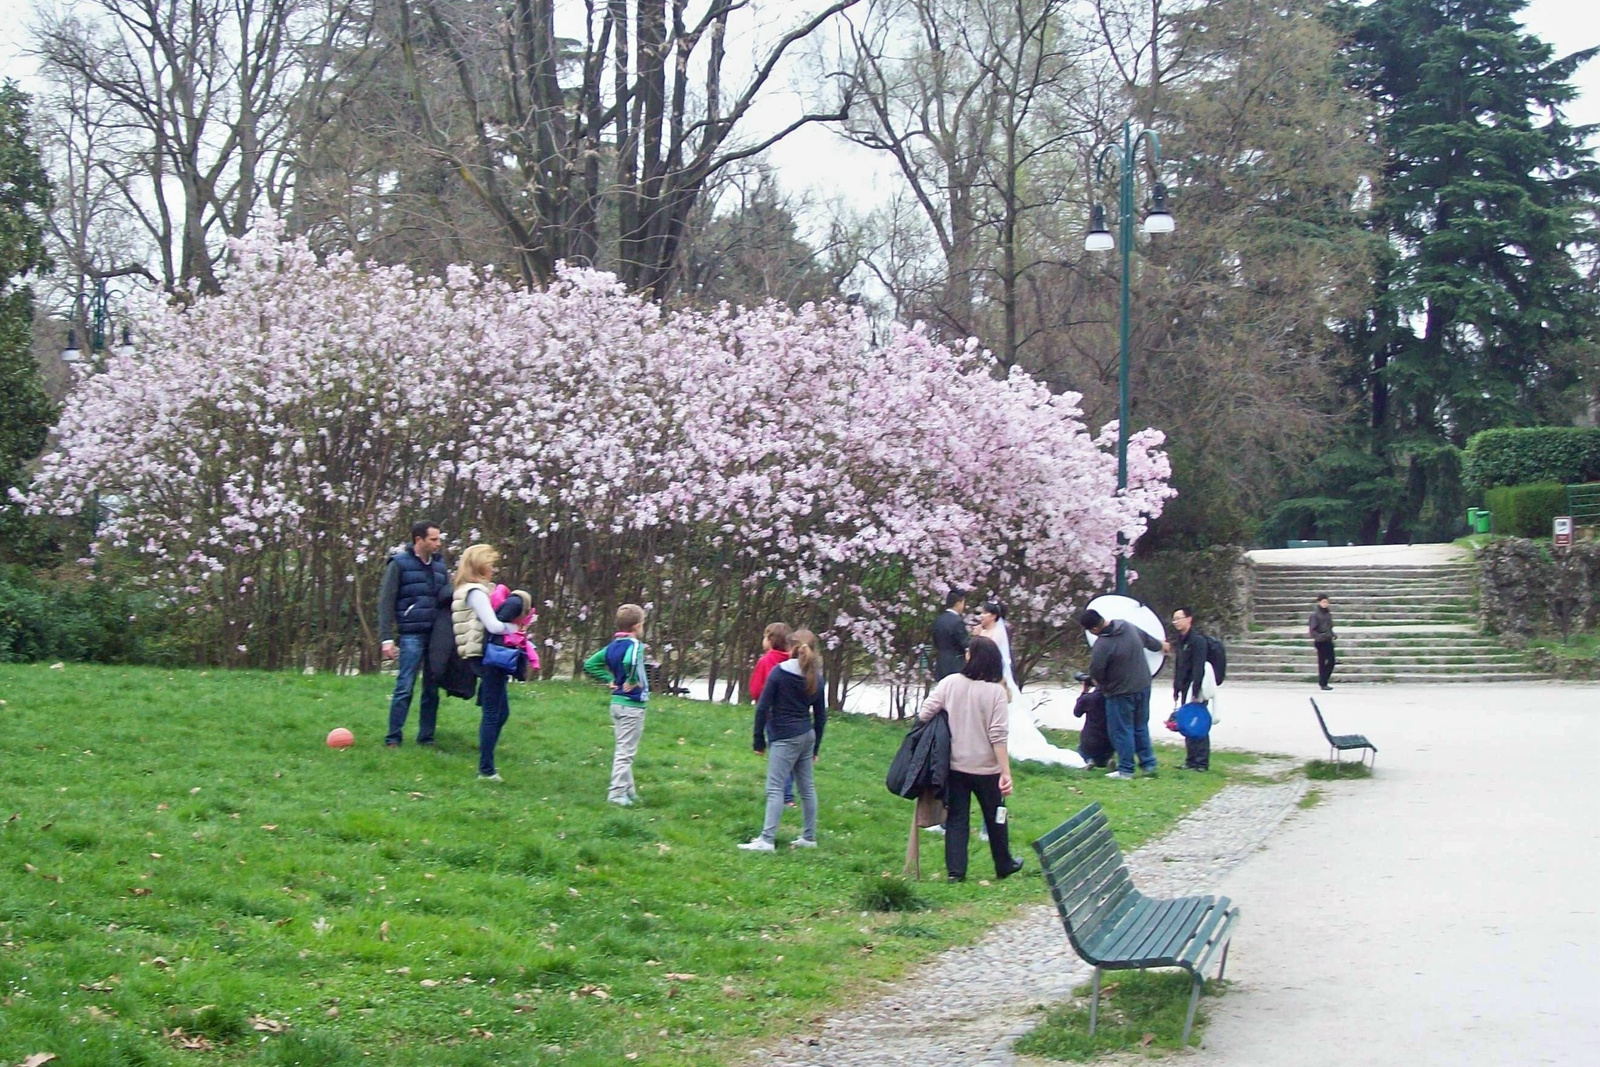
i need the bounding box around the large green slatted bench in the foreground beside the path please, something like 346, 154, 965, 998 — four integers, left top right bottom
1034, 803, 1238, 1046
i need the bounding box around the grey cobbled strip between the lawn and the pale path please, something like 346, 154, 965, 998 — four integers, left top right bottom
750, 768, 1306, 1067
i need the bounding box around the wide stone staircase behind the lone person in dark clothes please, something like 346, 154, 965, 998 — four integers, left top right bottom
1227, 553, 1546, 685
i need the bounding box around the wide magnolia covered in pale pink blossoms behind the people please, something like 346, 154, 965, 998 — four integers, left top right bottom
19, 230, 1171, 683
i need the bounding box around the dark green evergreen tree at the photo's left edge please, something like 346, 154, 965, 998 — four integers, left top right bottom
0, 82, 56, 506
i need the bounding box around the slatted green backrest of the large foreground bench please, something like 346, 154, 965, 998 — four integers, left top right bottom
1034, 803, 1139, 955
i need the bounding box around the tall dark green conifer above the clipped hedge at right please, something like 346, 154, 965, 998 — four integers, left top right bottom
1333, 0, 1600, 441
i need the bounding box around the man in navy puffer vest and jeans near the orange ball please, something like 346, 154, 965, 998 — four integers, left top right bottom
378, 520, 451, 749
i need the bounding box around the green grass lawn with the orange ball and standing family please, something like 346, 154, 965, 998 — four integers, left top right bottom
0, 664, 1250, 1067
